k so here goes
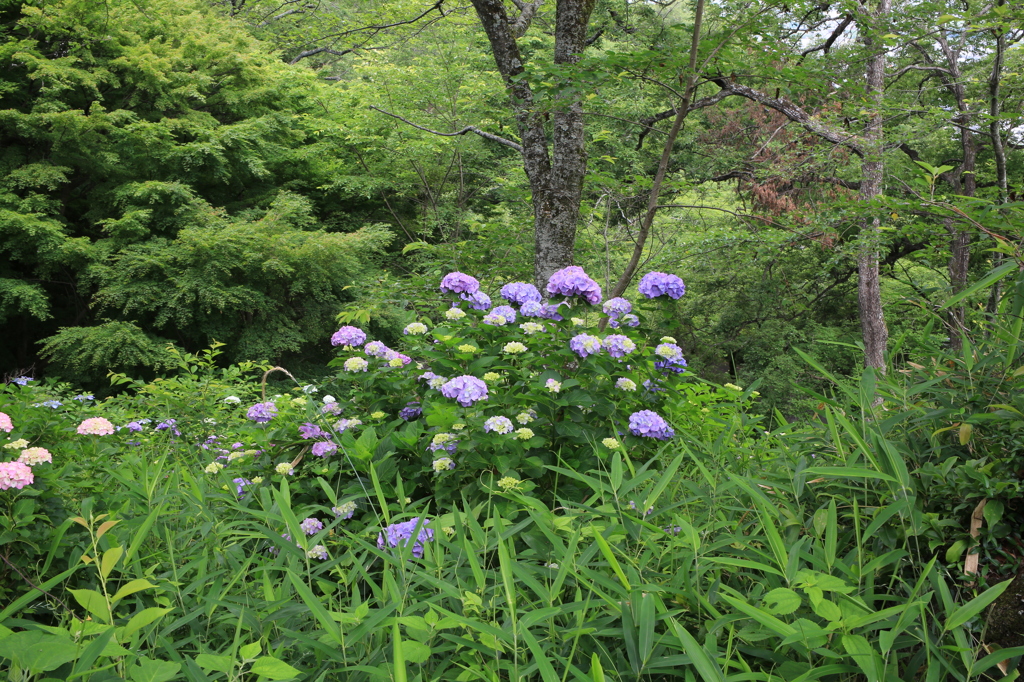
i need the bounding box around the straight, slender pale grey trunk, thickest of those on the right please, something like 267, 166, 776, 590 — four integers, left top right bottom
857, 0, 891, 373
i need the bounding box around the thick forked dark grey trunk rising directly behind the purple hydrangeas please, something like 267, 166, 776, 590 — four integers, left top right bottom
472, 0, 594, 288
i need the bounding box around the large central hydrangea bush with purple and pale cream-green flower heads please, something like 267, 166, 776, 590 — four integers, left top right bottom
243, 266, 700, 509
